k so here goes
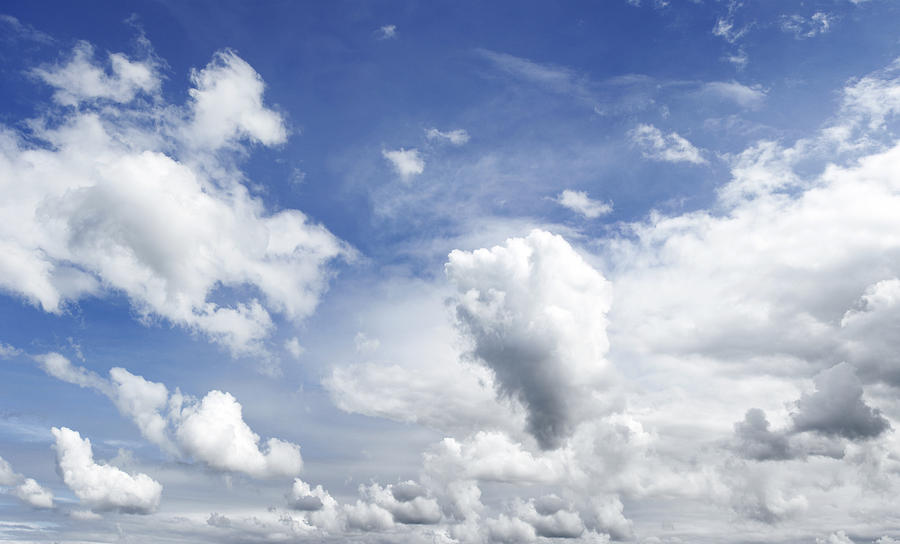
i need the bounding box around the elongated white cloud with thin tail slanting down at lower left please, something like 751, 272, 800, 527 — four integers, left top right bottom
34, 353, 303, 478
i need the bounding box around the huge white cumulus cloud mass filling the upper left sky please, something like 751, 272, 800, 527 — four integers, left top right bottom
0, 44, 350, 354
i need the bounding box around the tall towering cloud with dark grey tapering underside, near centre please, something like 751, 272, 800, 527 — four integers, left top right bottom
445, 230, 611, 448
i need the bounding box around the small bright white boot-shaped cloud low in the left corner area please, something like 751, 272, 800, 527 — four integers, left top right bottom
51, 427, 162, 514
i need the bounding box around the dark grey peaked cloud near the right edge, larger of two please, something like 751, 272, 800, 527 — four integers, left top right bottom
791, 363, 891, 440
